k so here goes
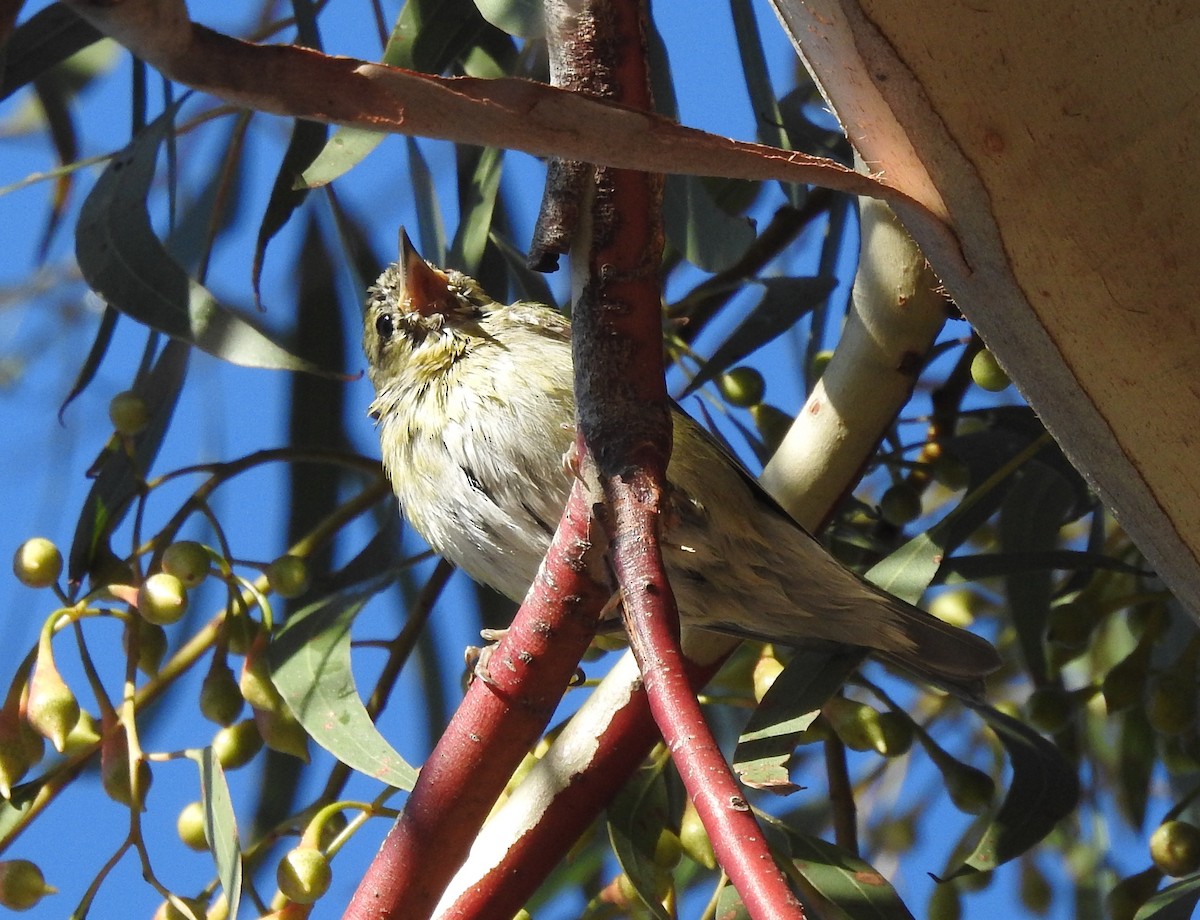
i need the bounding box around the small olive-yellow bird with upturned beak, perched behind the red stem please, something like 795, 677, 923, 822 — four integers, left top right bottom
364, 231, 1000, 687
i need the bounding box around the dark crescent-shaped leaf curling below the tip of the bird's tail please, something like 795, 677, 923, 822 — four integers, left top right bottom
947, 700, 1079, 880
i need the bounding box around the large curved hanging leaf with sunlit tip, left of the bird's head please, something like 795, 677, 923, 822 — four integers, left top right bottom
76, 109, 333, 373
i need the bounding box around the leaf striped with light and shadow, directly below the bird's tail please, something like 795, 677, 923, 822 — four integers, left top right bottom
733, 650, 864, 794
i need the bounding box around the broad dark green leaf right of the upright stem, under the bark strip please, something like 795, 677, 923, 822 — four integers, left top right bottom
662, 175, 755, 272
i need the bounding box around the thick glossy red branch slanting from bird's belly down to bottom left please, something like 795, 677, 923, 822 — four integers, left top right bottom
344, 483, 610, 920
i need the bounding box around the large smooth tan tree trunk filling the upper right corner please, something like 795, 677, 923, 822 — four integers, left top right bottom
774, 0, 1200, 613
